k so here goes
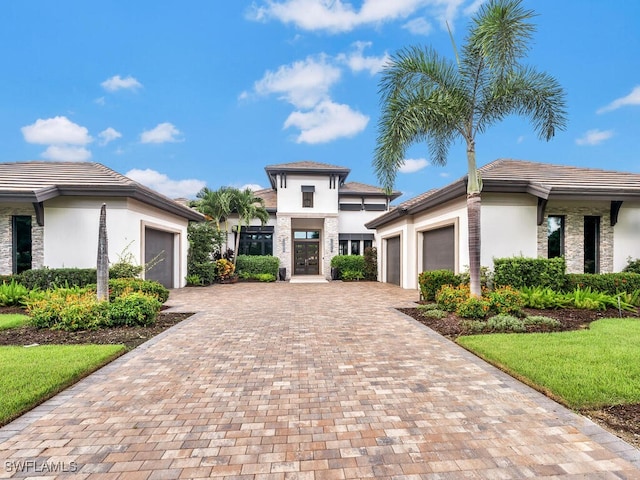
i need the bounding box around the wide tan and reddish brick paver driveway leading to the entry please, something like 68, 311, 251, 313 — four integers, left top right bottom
0, 282, 640, 480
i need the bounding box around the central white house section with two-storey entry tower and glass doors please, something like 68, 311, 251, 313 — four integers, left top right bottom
231, 161, 401, 279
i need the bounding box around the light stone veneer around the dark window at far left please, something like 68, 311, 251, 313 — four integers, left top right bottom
0, 205, 44, 275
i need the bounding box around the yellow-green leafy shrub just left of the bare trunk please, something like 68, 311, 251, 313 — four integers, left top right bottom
27, 288, 109, 331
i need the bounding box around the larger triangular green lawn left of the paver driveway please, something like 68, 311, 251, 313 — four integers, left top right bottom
0, 345, 125, 425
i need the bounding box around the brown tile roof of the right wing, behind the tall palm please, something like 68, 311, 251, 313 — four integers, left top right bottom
366, 159, 640, 228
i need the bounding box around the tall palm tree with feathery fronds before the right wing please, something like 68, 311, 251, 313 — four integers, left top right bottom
373, 0, 566, 296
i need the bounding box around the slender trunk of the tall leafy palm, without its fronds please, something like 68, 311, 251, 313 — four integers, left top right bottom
467, 140, 482, 297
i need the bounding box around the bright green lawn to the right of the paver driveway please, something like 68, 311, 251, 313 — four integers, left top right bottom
457, 318, 640, 409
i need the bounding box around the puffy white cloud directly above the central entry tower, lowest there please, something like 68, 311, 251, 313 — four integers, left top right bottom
284, 101, 369, 144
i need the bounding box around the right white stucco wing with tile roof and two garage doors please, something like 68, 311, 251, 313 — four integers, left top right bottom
366, 159, 640, 289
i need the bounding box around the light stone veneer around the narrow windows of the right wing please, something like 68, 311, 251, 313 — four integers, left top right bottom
538, 205, 613, 273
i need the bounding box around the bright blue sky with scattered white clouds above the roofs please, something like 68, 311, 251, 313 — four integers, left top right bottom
0, 0, 640, 199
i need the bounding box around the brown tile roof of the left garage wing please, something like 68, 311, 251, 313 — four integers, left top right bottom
0, 161, 204, 220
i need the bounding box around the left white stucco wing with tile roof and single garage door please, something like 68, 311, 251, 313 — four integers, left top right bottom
0, 162, 204, 288
